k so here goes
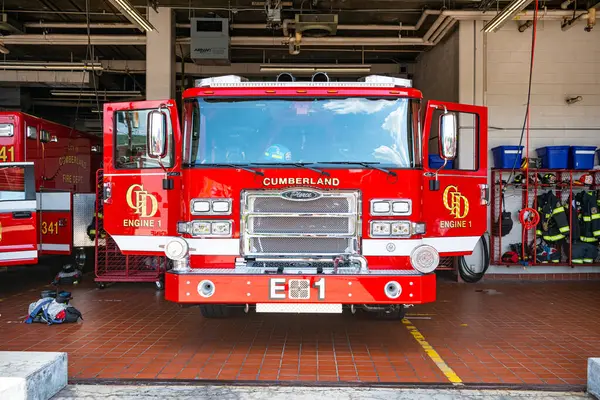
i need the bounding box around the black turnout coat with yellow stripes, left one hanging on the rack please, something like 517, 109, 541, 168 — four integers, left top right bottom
536, 191, 569, 243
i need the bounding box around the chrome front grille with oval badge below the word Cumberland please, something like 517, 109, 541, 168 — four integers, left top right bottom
241, 188, 360, 256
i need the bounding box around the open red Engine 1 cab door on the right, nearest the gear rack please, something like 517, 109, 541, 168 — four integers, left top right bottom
422, 101, 489, 256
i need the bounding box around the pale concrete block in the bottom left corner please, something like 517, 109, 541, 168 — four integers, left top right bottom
0, 351, 68, 400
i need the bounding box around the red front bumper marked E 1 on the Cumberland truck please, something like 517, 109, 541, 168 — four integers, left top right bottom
165, 269, 436, 304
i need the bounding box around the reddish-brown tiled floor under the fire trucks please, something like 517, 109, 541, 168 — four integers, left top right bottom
0, 266, 600, 385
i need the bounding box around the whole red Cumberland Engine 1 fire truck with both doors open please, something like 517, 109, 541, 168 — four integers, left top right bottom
104, 75, 488, 318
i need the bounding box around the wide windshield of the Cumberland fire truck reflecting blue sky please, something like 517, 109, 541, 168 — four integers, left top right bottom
184, 97, 419, 168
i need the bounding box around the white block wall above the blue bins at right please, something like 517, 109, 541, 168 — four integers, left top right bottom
459, 21, 600, 159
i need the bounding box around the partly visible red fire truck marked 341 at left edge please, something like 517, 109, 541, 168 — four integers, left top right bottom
0, 112, 102, 267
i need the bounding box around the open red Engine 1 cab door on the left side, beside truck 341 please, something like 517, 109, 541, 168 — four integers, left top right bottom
103, 100, 181, 255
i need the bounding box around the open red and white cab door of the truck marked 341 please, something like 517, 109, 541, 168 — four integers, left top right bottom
0, 162, 38, 267
